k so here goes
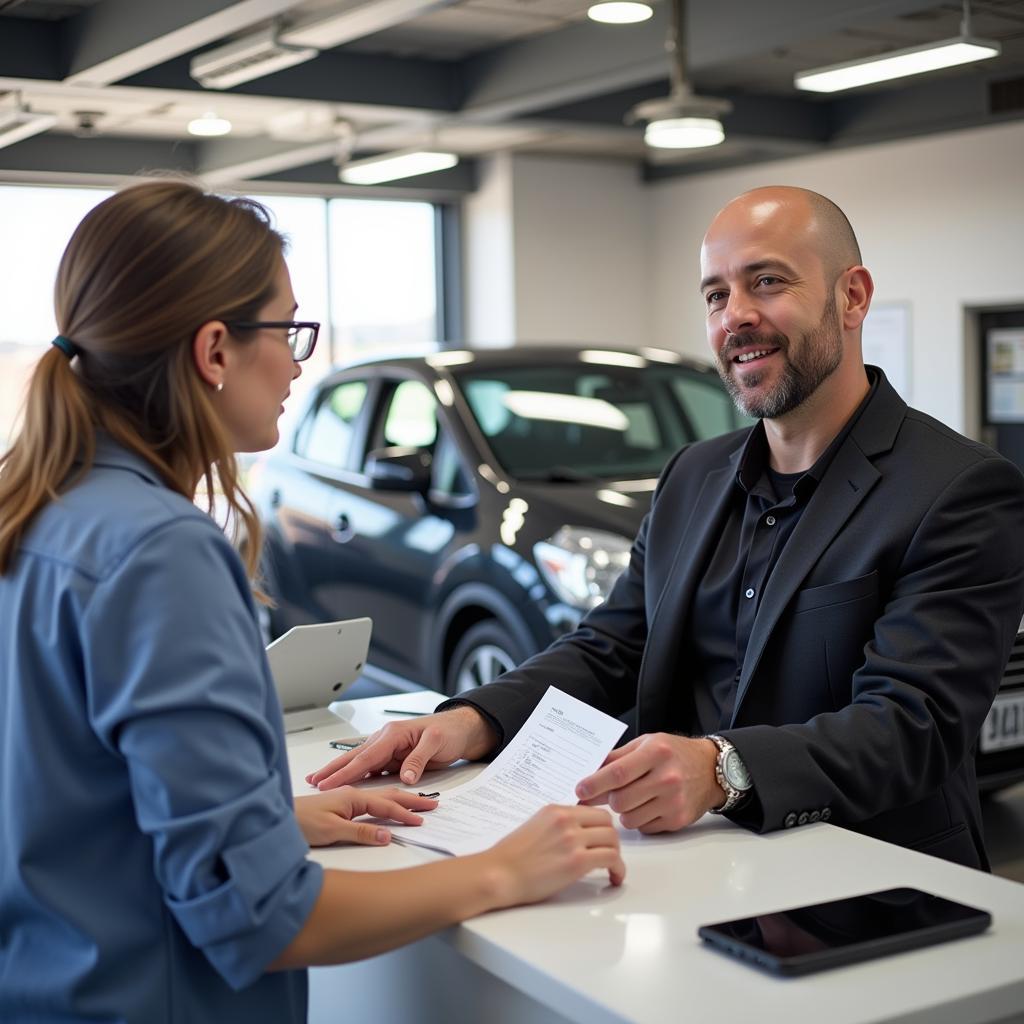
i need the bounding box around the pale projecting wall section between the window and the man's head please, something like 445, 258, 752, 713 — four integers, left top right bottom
463, 155, 651, 345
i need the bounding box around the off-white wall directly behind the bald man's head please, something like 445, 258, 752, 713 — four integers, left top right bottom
647, 122, 1024, 430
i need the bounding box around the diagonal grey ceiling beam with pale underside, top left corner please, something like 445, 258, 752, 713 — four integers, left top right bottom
65, 0, 301, 85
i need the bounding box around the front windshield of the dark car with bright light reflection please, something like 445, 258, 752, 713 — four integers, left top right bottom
453, 361, 751, 482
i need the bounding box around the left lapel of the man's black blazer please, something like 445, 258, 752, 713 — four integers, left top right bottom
637, 460, 738, 734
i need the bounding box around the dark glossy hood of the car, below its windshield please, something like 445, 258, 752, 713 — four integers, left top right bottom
513, 477, 657, 540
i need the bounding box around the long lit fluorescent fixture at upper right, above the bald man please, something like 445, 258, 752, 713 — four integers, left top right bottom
793, 36, 1001, 92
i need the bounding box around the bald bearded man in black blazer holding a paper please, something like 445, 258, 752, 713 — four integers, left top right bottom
310, 187, 1024, 867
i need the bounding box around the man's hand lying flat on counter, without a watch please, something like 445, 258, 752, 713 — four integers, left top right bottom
306, 706, 498, 790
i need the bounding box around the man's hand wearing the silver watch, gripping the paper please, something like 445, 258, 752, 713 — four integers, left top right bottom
577, 732, 725, 833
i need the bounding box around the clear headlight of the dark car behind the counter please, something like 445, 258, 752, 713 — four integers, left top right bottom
534, 526, 632, 610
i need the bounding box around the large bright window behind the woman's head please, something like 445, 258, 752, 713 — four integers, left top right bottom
0, 185, 439, 452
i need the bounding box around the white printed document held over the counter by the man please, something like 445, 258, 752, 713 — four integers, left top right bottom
391, 686, 626, 854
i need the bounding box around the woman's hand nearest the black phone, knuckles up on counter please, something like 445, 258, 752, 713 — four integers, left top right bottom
477, 804, 626, 906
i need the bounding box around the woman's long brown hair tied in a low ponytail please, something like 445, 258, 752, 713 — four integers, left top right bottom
0, 180, 284, 578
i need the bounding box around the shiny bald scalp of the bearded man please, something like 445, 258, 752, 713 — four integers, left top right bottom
705, 185, 861, 285
